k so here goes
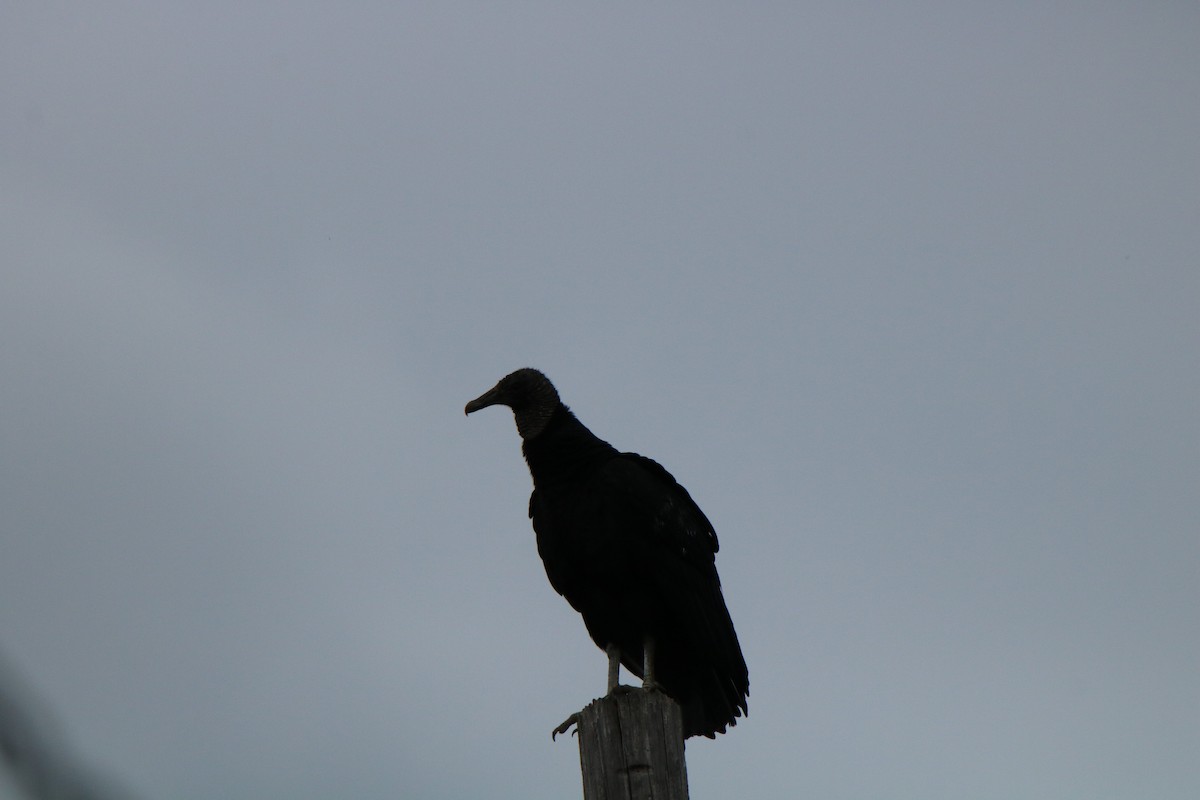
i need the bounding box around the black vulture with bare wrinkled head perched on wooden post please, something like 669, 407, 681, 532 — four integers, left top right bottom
466, 367, 750, 739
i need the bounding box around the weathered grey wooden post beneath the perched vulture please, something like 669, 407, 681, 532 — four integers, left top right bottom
578, 690, 688, 800
